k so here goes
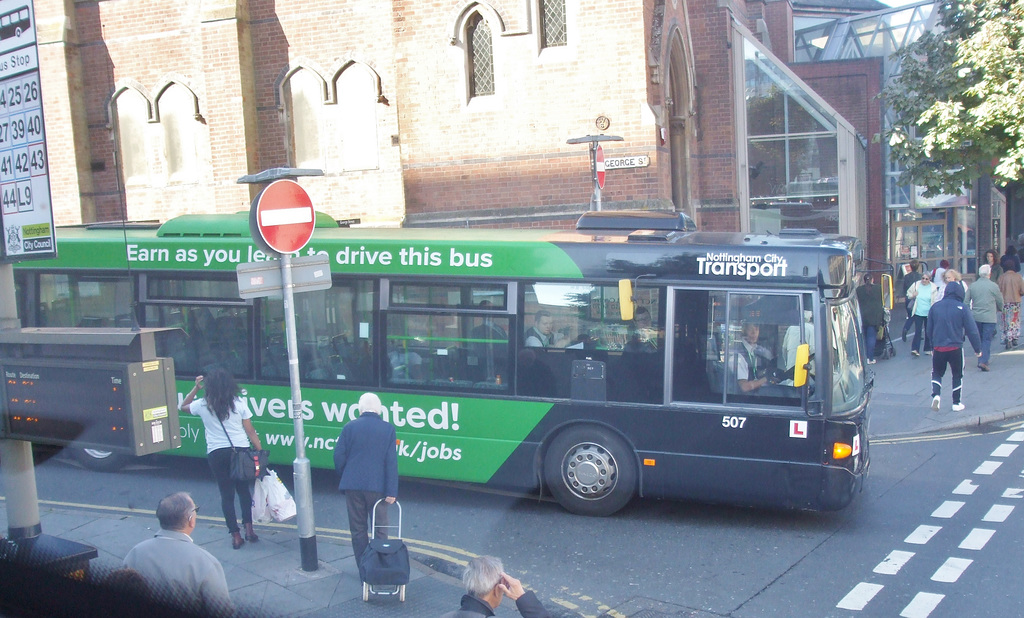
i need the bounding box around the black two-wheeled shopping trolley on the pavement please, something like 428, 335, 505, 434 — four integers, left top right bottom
358, 499, 410, 602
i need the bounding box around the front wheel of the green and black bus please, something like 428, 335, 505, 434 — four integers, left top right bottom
544, 427, 637, 517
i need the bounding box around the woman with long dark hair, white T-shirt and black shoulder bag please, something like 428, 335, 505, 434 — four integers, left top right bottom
180, 367, 263, 549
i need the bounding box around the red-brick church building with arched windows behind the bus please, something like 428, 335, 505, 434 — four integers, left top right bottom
35, 0, 887, 255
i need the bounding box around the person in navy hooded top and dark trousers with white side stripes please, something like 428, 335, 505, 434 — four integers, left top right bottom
928, 281, 981, 412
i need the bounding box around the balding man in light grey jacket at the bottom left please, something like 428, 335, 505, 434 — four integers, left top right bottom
124, 491, 233, 616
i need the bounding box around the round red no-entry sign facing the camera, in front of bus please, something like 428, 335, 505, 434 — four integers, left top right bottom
249, 179, 316, 254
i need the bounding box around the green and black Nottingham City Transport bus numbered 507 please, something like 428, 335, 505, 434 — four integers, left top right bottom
15, 211, 870, 515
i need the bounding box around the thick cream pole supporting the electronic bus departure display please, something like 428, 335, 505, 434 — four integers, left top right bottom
0, 264, 43, 540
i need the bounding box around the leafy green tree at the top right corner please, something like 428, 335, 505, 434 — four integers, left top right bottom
883, 0, 1024, 196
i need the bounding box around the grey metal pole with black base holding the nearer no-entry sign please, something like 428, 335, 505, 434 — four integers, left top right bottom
281, 254, 319, 571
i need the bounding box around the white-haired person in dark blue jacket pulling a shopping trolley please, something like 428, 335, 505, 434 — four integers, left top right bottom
334, 393, 398, 564
